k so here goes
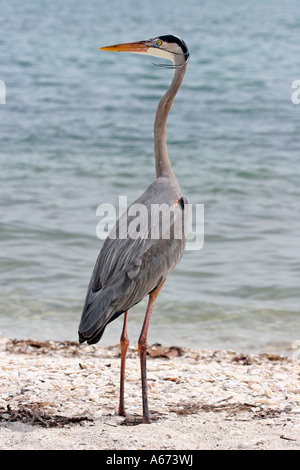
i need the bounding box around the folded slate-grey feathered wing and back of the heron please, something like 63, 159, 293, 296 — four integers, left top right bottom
79, 178, 185, 342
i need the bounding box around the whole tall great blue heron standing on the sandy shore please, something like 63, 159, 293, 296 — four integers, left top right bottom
79, 35, 189, 423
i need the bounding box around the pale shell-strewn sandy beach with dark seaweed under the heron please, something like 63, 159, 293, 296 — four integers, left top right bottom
0, 338, 300, 451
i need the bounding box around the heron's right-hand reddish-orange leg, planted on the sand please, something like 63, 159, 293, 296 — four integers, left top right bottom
138, 280, 165, 424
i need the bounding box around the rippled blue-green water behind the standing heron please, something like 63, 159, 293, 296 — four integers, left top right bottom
0, 0, 300, 351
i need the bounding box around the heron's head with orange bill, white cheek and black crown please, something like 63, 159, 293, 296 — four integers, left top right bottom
99, 35, 190, 65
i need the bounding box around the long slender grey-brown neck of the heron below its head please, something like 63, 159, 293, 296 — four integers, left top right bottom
154, 57, 187, 178
